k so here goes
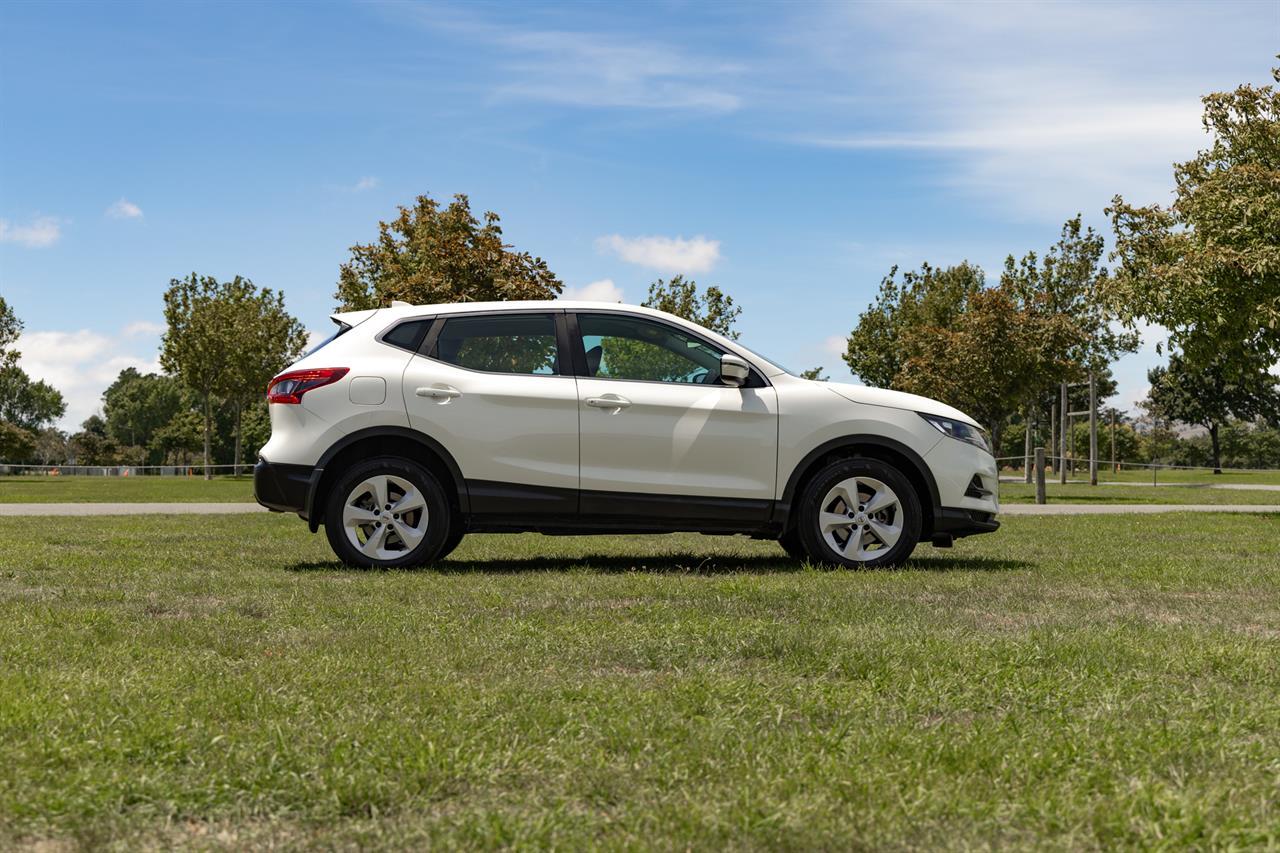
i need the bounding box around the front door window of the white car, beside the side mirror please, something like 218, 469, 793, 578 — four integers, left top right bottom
577, 314, 722, 386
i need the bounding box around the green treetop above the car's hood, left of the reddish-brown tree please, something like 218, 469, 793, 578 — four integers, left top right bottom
844, 261, 986, 388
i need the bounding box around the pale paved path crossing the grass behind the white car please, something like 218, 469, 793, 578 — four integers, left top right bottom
0, 503, 1280, 516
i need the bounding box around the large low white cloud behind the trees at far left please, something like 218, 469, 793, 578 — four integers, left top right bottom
17, 323, 160, 432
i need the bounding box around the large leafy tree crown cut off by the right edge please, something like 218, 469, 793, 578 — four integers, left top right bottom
1106, 61, 1280, 374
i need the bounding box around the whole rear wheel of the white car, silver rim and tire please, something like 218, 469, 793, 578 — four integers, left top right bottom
324, 457, 456, 569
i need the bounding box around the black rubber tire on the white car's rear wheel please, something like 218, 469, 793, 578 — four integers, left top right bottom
324, 456, 460, 569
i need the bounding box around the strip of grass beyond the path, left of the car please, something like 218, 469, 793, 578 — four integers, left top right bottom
0, 475, 253, 503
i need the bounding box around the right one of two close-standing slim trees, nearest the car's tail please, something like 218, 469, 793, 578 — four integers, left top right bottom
215, 277, 307, 474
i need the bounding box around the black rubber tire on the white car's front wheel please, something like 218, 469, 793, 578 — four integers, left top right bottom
796, 459, 924, 569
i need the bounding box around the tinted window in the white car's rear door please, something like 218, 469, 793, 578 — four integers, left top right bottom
431, 314, 559, 375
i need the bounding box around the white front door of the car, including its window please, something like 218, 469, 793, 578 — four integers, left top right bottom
576, 311, 778, 520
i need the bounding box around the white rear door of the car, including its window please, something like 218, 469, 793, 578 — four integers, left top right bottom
403, 311, 579, 517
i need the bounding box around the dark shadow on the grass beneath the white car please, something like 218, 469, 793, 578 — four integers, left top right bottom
287, 555, 1032, 575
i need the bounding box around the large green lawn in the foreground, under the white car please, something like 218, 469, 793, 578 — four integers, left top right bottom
0, 515, 1280, 849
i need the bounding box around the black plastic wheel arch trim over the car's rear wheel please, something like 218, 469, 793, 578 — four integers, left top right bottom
306, 427, 471, 533
